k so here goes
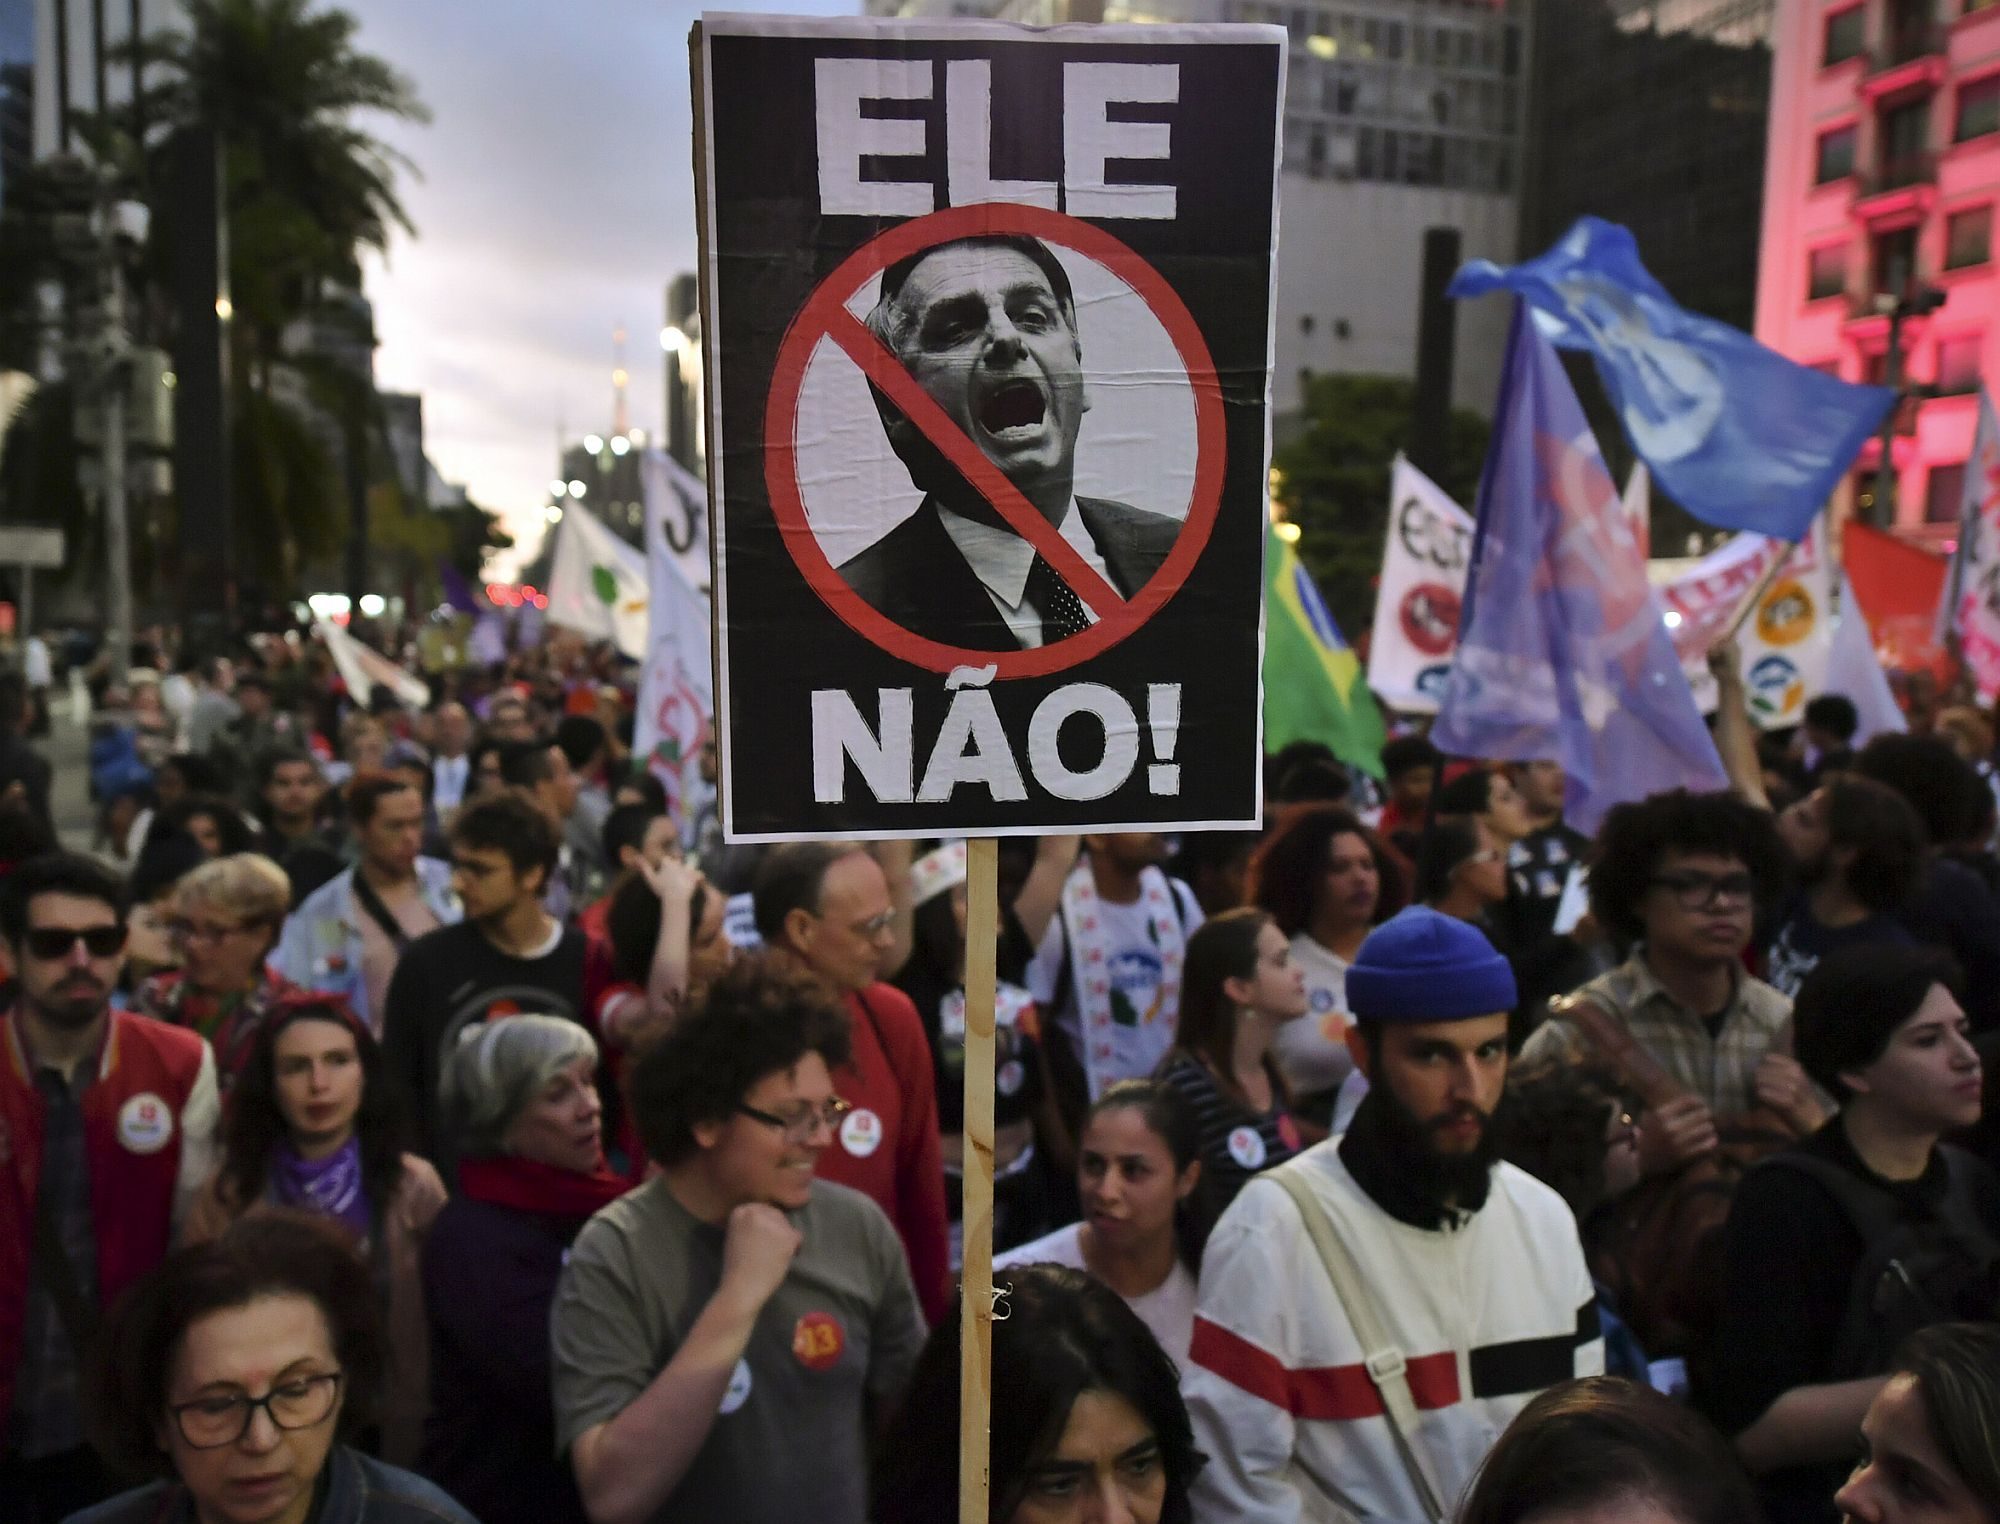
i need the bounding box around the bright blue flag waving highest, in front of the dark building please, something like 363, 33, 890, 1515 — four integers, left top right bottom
1450, 216, 1896, 542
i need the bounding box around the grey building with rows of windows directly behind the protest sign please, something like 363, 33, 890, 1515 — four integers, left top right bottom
852, 0, 1528, 422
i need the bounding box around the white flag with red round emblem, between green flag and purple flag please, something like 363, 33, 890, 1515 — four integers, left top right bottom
1368, 456, 1472, 714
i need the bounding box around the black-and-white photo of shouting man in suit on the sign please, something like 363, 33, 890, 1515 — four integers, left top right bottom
840, 236, 1180, 650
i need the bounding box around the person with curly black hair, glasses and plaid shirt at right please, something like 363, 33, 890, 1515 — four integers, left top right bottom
1522, 790, 1828, 1176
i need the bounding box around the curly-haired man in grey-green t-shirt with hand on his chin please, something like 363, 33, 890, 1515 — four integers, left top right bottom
550, 958, 920, 1524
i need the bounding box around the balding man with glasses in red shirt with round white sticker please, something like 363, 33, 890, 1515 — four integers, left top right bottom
752, 842, 952, 1322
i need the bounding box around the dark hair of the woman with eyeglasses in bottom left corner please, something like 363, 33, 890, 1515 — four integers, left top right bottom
86, 1210, 388, 1478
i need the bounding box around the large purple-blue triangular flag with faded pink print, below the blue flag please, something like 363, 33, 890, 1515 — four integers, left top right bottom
1430, 306, 1728, 834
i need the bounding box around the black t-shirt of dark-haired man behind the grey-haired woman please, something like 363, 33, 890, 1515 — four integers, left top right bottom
382, 922, 584, 1160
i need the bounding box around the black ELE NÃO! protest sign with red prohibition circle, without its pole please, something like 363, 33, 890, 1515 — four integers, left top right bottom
696, 16, 1284, 840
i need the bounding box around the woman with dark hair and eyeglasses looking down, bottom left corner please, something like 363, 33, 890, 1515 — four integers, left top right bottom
70, 1214, 476, 1524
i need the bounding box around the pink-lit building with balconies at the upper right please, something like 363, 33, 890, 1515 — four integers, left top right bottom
1756, 0, 2000, 540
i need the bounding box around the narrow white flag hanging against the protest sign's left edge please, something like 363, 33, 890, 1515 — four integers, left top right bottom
632, 484, 716, 820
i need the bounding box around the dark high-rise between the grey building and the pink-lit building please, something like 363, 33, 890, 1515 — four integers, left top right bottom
1520, 0, 1774, 328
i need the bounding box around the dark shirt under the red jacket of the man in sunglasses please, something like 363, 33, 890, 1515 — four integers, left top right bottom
6, 1060, 98, 1460
